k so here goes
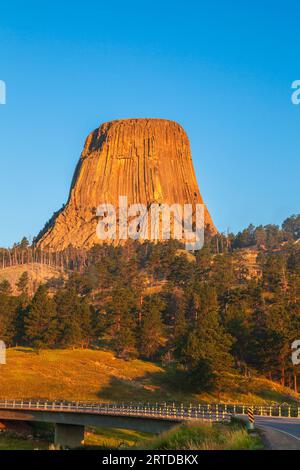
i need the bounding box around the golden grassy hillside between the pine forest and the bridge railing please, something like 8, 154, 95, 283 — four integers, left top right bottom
0, 348, 295, 404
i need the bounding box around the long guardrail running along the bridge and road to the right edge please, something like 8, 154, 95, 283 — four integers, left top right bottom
0, 400, 300, 422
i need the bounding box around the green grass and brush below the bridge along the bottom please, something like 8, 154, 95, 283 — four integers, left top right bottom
0, 422, 263, 450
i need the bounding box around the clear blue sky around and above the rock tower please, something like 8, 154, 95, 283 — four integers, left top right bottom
0, 0, 300, 246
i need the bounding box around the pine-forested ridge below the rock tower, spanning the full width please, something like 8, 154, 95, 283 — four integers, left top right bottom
0, 215, 300, 391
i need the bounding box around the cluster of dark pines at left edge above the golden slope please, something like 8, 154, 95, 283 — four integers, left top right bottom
0, 272, 96, 350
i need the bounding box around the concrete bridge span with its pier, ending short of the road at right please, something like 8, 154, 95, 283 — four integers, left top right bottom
0, 400, 230, 448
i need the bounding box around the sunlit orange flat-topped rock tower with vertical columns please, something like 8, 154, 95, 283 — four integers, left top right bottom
38, 119, 216, 251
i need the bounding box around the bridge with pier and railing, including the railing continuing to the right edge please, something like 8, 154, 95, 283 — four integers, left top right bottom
0, 400, 300, 448
